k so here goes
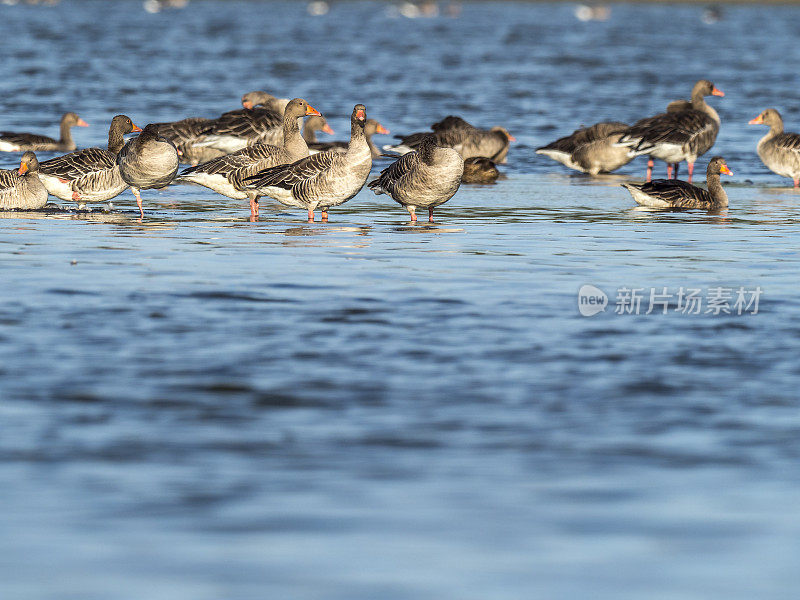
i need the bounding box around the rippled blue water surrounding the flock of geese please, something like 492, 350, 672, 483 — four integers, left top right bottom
0, 0, 800, 600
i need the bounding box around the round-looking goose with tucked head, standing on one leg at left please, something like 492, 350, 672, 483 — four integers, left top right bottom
117, 123, 178, 217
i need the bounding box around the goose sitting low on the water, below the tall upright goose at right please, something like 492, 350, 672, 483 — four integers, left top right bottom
622, 156, 733, 210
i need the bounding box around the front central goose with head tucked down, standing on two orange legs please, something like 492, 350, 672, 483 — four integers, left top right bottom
369, 135, 464, 223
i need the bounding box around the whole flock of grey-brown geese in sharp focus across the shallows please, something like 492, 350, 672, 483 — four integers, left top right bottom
0, 80, 800, 222
